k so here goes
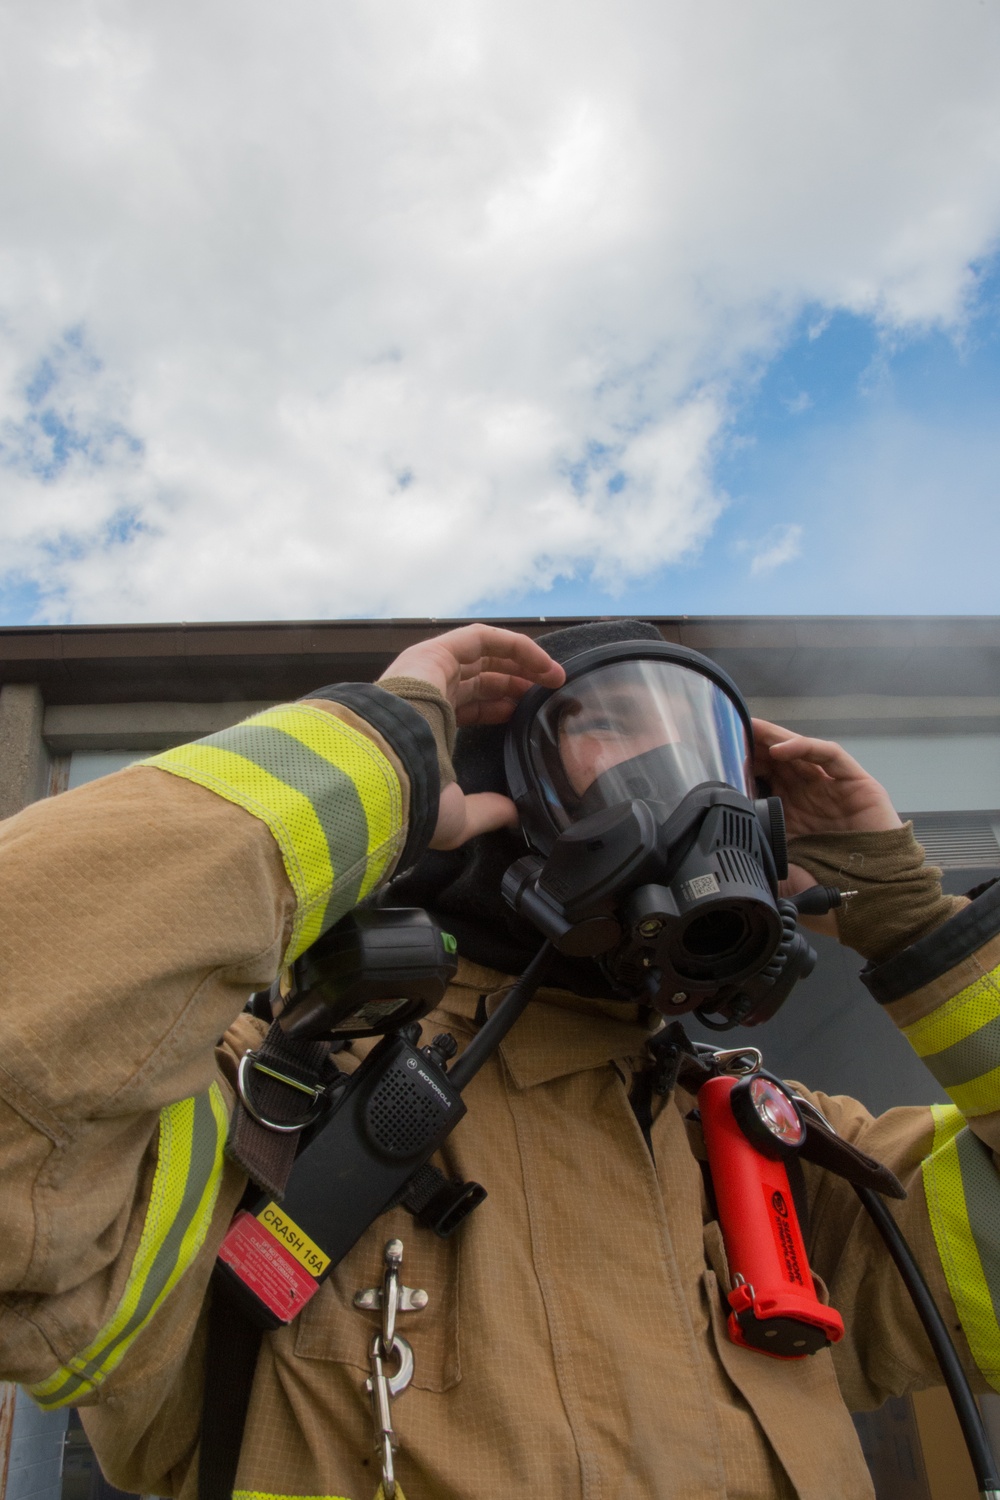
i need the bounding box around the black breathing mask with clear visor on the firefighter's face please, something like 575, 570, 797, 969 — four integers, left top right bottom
504, 641, 816, 1029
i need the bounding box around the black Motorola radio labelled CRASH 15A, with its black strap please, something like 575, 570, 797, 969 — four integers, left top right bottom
198, 1025, 486, 1500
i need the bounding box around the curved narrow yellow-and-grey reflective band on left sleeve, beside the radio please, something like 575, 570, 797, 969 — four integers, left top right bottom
28, 1083, 229, 1412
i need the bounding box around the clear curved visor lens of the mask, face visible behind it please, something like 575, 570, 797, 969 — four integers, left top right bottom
529, 660, 756, 830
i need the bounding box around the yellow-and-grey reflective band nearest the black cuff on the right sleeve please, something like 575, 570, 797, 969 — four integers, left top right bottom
903, 968, 1000, 1115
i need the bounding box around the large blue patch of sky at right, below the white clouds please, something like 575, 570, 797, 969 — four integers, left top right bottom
472, 260, 1000, 615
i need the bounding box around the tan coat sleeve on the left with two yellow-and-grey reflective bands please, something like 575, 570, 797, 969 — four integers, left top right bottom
0, 687, 438, 1464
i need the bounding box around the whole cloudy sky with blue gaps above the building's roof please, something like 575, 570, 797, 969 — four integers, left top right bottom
0, 0, 1000, 624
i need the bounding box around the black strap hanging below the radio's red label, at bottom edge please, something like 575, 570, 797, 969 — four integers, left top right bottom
198, 1287, 264, 1500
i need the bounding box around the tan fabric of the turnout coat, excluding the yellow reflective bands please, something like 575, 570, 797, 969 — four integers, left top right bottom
0, 711, 989, 1500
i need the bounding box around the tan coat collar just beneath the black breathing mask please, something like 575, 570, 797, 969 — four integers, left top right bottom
442, 959, 663, 1089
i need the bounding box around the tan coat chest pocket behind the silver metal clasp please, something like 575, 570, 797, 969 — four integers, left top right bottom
295, 1209, 462, 1392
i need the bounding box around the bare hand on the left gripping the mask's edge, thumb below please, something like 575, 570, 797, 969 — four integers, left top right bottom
377, 626, 565, 849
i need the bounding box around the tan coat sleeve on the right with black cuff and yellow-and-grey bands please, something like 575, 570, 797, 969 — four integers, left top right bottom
808, 884, 1000, 1410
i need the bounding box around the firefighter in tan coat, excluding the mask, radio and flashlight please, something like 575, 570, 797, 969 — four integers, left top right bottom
0, 623, 1000, 1500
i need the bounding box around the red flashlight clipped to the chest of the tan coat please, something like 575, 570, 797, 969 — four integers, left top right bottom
699, 1074, 844, 1359
